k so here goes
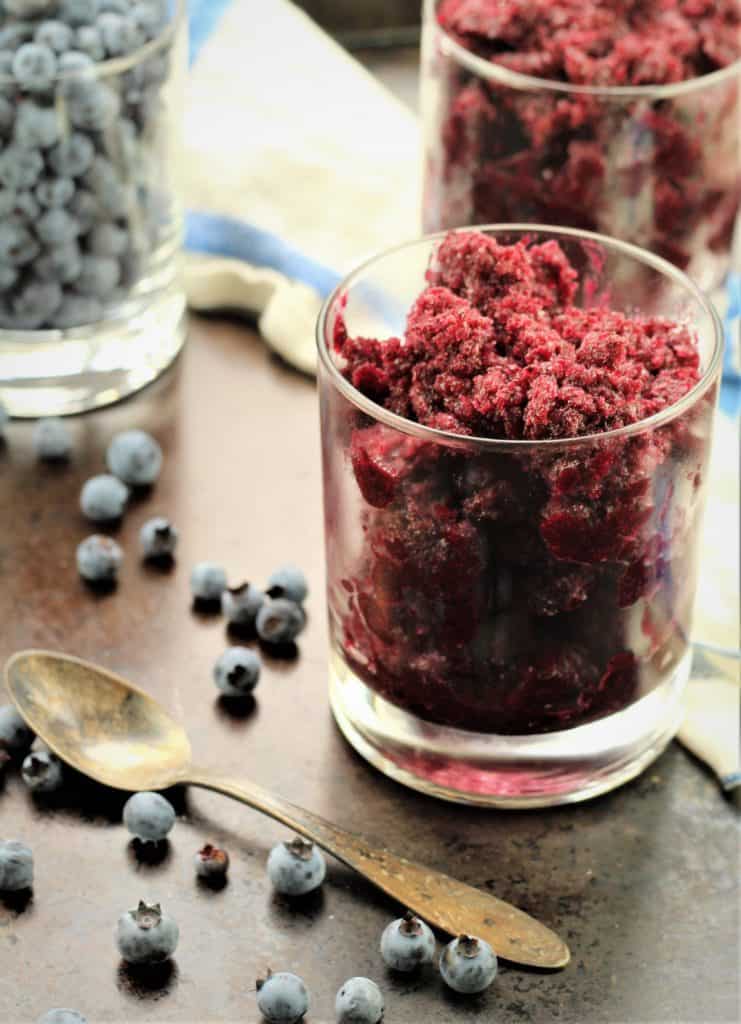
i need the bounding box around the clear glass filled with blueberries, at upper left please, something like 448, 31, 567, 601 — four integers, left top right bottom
0, 0, 186, 417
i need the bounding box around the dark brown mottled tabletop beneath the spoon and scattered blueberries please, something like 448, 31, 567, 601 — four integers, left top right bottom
0, 319, 739, 1024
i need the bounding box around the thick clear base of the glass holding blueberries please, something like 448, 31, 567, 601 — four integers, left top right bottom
0, 284, 186, 417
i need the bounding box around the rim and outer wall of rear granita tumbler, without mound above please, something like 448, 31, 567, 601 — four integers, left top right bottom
422, 0, 741, 289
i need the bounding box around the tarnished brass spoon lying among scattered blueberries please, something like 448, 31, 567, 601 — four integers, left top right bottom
5, 650, 569, 968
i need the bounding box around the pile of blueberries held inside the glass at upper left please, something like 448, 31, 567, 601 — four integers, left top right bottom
0, 0, 170, 330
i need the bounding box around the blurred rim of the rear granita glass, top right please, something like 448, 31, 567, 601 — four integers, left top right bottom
425, 0, 741, 99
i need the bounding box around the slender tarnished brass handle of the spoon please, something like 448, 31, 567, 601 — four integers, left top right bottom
183, 769, 570, 968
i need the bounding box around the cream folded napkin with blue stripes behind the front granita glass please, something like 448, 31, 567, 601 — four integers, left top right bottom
181, 0, 741, 786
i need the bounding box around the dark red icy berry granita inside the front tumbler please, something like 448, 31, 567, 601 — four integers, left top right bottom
322, 230, 715, 734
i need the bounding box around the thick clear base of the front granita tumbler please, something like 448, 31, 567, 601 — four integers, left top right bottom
330, 650, 691, 808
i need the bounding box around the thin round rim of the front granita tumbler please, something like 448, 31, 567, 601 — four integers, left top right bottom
316, 223, 725, 454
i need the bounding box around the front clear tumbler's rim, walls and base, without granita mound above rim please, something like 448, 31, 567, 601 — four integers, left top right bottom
318, 224, 723, 807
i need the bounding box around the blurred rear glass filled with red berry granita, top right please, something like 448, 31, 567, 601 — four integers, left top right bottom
423, 0, 741, 287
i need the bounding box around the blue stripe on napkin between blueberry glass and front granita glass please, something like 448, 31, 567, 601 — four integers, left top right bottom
185, 210, 341, 297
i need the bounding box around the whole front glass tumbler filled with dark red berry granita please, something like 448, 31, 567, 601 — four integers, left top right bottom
318, 224, 723, 806
